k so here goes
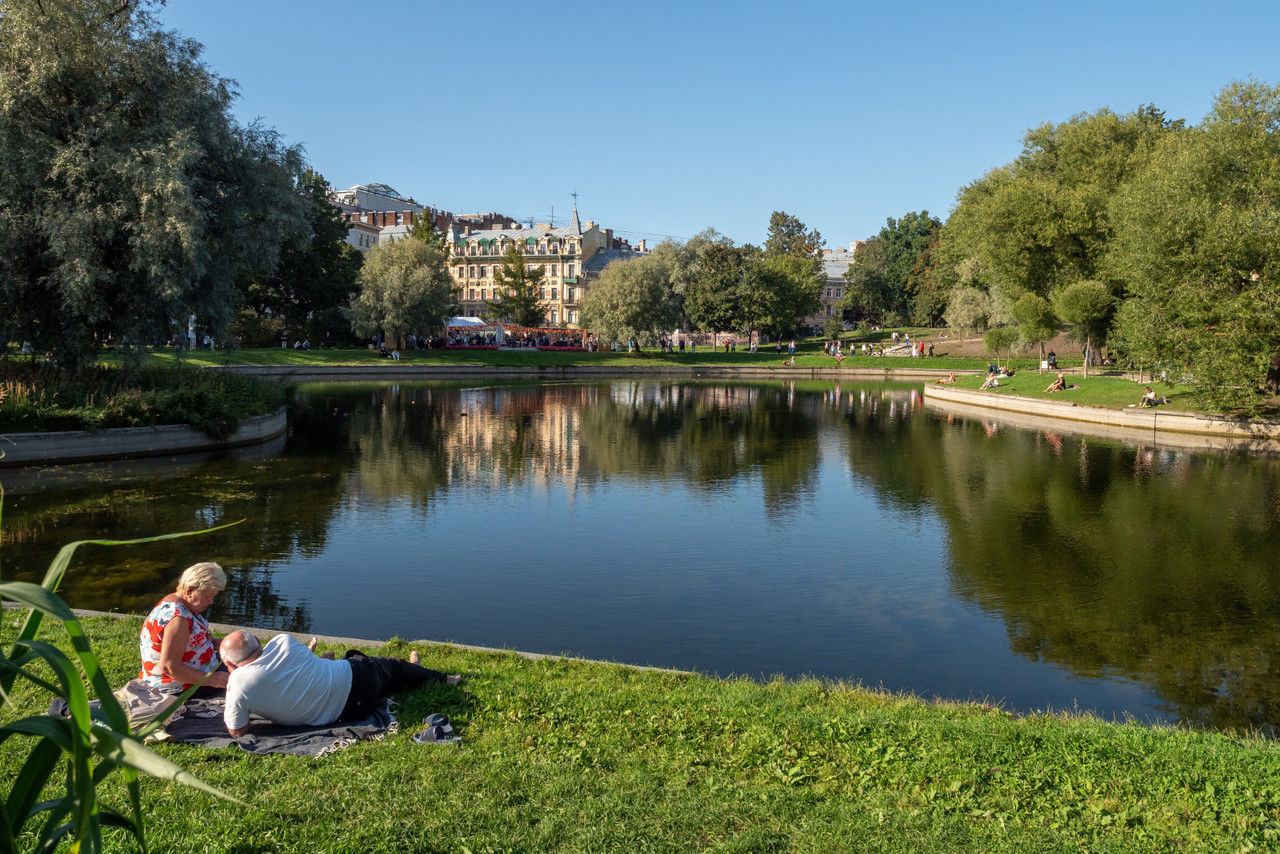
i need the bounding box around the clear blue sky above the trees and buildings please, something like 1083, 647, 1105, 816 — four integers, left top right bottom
160, 0, 1280, 246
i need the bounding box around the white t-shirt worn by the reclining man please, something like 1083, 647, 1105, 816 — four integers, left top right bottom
223, 635, 351, 730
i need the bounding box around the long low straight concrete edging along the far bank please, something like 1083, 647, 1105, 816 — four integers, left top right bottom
216, 365, 977, 383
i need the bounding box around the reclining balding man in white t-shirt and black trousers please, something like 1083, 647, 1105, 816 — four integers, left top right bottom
221, 630, 462, 739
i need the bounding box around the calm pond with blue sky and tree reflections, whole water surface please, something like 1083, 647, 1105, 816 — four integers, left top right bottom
10, 380, 1280, 730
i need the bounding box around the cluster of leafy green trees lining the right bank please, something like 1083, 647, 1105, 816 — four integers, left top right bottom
842, 79, 1280, 411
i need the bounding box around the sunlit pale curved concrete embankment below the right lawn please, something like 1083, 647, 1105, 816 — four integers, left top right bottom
924, 385, 1280, 453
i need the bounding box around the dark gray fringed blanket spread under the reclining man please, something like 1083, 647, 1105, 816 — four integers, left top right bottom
49, 698, 396, 757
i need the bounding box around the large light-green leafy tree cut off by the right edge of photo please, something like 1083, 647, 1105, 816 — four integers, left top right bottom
1108, 81, 1280, 410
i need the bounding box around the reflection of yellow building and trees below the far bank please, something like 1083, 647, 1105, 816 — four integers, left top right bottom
348, 382, 818, 512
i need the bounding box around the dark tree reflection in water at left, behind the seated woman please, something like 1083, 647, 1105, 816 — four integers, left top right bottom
4, 425, 360, 630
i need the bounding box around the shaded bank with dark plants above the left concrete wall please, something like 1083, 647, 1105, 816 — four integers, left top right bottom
0, 359, 287, 438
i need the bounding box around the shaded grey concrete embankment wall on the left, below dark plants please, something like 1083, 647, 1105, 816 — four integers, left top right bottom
0, 406, 289, 466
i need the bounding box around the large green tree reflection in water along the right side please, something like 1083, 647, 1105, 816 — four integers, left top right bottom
849, 409, 1280, 727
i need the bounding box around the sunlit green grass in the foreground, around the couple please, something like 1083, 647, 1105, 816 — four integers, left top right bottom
0, 612, 1280, 851
